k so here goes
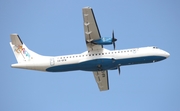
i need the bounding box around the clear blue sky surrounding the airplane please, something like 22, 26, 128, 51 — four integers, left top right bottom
0, 0, 180, 111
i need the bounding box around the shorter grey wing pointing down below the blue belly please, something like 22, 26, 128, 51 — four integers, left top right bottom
93, 70, 109, 91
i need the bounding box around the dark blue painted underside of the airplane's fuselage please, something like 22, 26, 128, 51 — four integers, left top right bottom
46, 56, 166, 72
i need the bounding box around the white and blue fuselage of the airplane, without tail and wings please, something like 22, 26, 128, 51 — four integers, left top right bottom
12, 47, 169, 72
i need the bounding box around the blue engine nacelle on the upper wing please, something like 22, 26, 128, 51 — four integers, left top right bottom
91, 37, 113, 45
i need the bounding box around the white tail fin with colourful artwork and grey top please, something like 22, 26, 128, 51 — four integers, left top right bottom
10, 34, 40, 63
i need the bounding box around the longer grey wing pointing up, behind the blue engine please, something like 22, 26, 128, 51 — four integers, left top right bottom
82, 7, 103, 51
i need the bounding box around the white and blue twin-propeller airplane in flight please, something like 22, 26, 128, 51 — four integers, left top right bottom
10, 7, 170, 91
